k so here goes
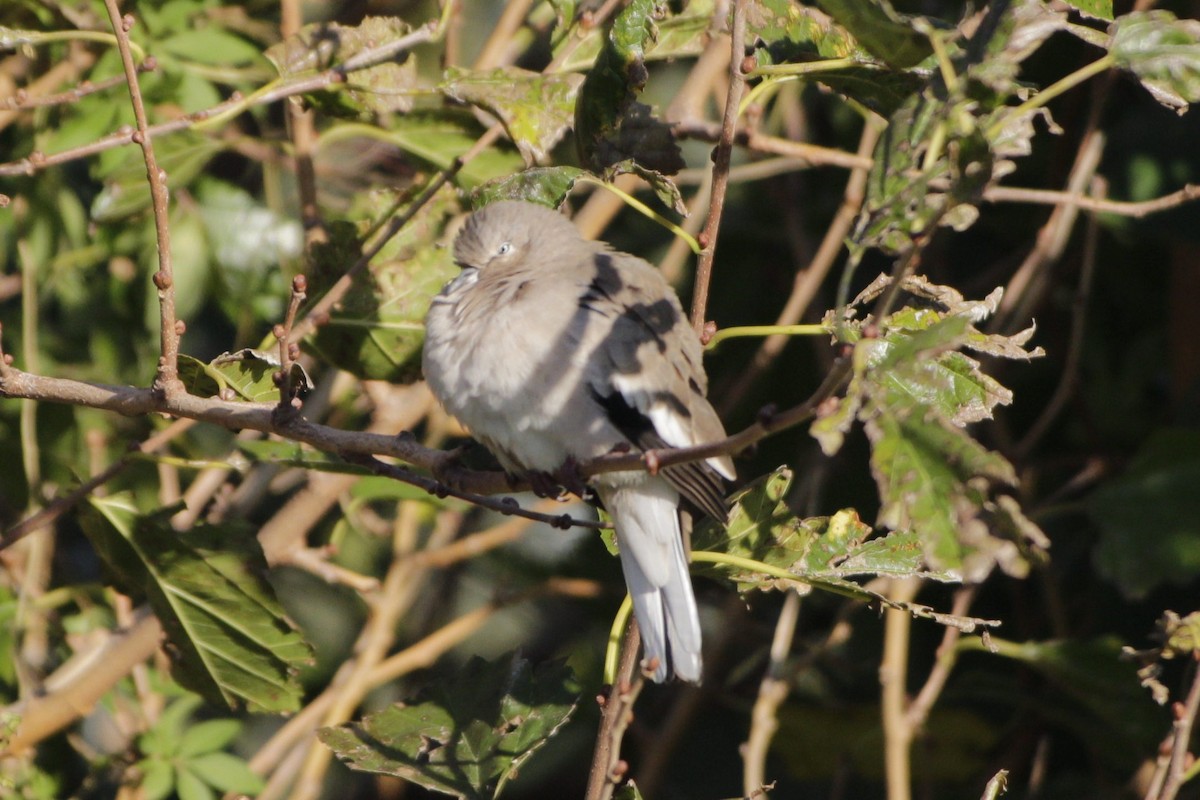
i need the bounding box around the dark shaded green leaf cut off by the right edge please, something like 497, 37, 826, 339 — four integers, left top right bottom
1087, 428, 1200, 600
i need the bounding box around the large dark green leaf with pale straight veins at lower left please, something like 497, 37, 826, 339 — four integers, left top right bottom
84, 494, 310, 711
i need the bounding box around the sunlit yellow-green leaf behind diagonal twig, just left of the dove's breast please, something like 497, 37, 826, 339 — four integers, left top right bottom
308, 186, 458, 383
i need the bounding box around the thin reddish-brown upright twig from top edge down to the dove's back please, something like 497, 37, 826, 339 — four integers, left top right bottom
691, 0, 746, 336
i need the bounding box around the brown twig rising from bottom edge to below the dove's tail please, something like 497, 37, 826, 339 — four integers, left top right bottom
584, 616, 646, 800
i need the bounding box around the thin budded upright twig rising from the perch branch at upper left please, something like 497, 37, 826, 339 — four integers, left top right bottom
104, 0, 184, 396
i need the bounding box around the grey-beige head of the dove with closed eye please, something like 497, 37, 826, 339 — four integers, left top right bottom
454, 200, 580, 270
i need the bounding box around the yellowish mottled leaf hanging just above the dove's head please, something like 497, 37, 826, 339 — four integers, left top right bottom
439, 67, 583, 163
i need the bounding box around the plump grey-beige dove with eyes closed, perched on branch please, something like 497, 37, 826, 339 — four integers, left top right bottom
425, 200, 734, 682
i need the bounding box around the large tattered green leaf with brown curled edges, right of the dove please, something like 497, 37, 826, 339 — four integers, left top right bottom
811, 278, 1048, 581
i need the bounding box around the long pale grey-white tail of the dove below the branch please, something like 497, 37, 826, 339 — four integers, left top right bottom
600, 479, 701, 682
